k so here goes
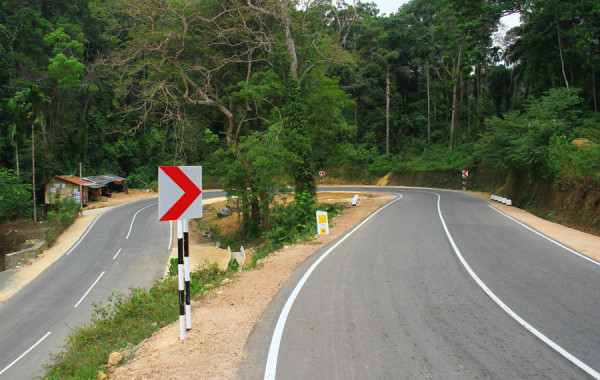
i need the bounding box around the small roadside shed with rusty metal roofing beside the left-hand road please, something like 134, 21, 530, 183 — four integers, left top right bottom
44, 174, 127, 204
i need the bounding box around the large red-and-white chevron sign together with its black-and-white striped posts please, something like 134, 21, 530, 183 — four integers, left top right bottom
158, 166, 202, 340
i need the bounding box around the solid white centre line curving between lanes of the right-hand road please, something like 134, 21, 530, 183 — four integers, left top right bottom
434, 193, 600, 379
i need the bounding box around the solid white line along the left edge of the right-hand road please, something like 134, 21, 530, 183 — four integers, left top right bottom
264, 194, 402, 380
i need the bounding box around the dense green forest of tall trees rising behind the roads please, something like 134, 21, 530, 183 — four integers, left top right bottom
0, 0, 600, 235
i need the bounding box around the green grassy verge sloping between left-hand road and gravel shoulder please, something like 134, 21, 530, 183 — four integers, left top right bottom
42, 265, 232, 379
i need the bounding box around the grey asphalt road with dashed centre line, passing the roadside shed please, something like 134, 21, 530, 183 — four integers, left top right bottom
0, 191, 224, 380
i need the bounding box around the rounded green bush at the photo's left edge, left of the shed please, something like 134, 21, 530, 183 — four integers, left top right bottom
0, 168, 33, 222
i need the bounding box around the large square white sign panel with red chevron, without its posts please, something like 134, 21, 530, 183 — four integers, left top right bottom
158, 166, 202, 222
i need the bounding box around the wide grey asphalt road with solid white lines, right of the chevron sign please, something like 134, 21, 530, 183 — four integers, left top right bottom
239, 188, 600, 379
